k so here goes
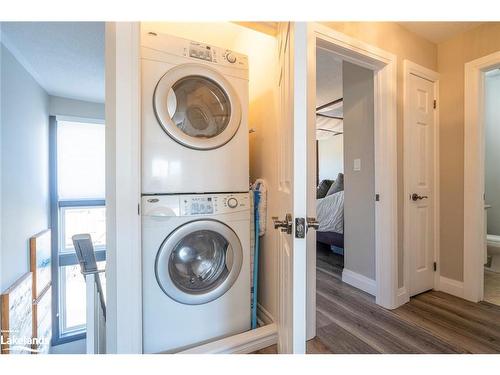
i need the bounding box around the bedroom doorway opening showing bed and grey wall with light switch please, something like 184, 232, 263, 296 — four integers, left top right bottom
316, 48, 376, 295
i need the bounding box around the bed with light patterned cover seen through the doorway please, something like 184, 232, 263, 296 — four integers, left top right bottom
316, 190, 344, 249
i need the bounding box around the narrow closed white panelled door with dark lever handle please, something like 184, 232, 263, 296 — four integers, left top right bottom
405, 74, 435, 296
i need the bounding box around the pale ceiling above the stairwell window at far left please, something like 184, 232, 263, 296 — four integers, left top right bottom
2, 22, 105, 103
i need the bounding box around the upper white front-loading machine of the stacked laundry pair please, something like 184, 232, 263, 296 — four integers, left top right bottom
141, 32, 249, 194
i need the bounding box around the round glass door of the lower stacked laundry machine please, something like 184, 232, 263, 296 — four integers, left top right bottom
155, 220, 243, 305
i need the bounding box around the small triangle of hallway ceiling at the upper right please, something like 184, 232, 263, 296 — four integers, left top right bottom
398, 22, 483, 44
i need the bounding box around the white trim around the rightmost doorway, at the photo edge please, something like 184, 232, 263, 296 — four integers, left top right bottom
463, 51, 500, 302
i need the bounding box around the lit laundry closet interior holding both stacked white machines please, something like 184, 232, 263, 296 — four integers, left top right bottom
140, 22, 279, 353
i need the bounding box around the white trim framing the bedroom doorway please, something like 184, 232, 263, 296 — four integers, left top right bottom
307, 23, 398, 344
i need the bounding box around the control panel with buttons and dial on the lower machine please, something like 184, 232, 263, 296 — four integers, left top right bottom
180, 193, 250, 216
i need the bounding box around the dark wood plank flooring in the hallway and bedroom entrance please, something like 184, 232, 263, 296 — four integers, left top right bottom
259, 248, 500, 354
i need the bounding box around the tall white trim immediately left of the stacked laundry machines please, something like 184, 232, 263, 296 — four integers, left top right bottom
106, 22, 142, 354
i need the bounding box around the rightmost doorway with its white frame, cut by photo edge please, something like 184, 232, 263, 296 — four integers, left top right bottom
463, 52, 500, 302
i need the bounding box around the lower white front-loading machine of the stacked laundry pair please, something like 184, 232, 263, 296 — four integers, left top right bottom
142, 193, 250, 353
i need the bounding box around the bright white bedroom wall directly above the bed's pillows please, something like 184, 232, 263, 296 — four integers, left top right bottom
318, 134, 344, 181
